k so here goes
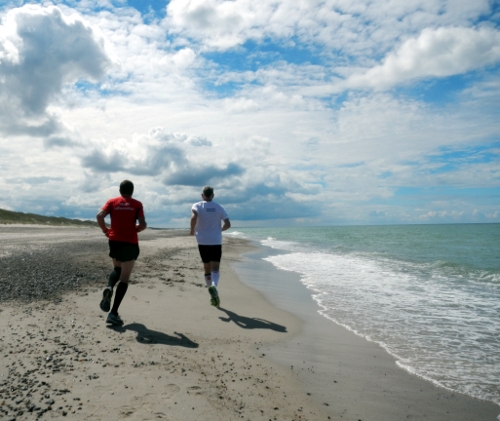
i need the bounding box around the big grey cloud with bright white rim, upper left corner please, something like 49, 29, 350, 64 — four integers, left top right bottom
0, 5, 110, 136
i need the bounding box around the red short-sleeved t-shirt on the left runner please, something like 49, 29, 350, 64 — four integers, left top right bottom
102, 196, 144, 244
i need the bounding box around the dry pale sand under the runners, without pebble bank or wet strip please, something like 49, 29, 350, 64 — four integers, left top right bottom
0, 227, 328, 421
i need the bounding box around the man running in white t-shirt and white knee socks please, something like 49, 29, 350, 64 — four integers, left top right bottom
190, 186, 231, 307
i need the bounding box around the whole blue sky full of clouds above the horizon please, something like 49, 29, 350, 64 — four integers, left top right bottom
0, 0, 500, 228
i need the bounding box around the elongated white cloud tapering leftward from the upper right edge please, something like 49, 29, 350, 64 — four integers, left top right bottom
346, 27, 500, 89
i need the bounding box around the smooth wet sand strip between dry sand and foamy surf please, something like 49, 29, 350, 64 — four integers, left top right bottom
233, 243, 500, 421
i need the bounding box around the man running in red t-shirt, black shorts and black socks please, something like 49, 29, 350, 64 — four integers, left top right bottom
96, 180, 147, 325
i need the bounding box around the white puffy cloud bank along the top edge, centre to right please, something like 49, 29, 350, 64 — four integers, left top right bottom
166, 0, 489, 60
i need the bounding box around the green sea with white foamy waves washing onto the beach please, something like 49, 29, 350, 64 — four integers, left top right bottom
230, 224, 500, 405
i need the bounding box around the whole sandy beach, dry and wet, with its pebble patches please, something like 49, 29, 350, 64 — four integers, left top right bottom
0, 226, 500, 421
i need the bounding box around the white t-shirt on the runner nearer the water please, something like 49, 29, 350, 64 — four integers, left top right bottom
191, 201, 229, 246
